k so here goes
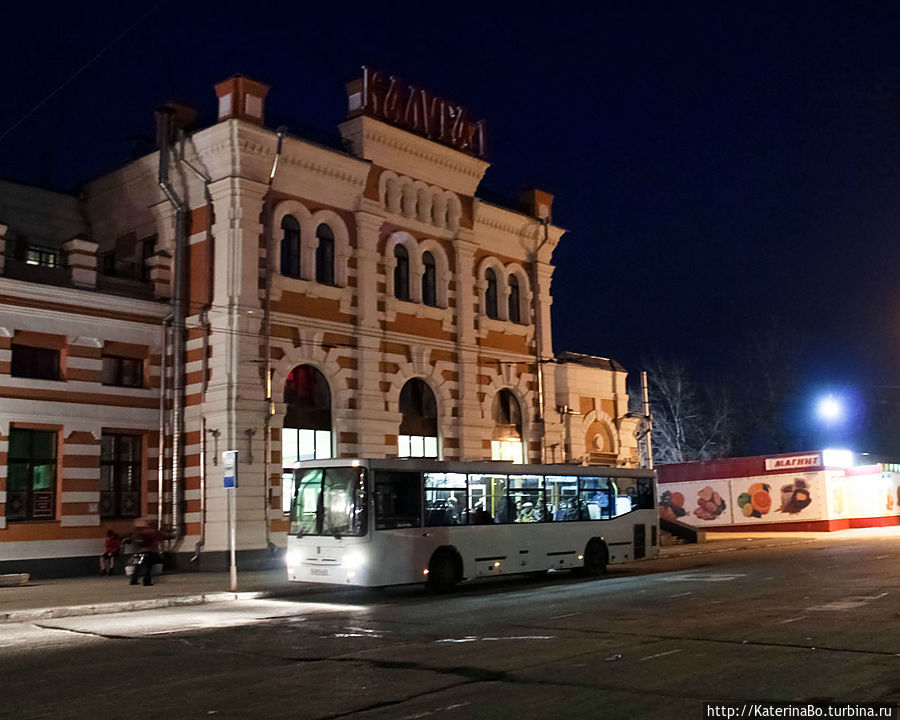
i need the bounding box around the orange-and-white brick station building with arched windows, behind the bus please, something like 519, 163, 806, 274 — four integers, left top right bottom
0, 69, 637, 576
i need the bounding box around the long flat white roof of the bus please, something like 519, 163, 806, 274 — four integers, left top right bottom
294, 458, 656, 477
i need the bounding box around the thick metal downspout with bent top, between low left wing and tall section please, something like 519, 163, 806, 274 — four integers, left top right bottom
156, 110, 187, 545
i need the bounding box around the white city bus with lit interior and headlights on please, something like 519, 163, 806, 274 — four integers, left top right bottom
286, 459, 659, 592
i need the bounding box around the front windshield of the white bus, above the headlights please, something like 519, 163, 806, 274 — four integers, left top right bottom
291, 467, 367, 538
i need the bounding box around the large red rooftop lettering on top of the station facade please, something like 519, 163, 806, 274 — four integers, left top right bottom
347, 66, 487, 158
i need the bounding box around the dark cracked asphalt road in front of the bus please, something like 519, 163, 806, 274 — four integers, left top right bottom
0, 539, 900, 720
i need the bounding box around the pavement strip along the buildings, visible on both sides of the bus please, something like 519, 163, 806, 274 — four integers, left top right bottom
0, 527, 900, 623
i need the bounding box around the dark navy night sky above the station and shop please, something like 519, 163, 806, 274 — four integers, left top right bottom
0, 0, 900, 450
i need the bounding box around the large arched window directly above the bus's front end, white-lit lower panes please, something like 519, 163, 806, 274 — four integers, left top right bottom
281, 365, 331, 512
